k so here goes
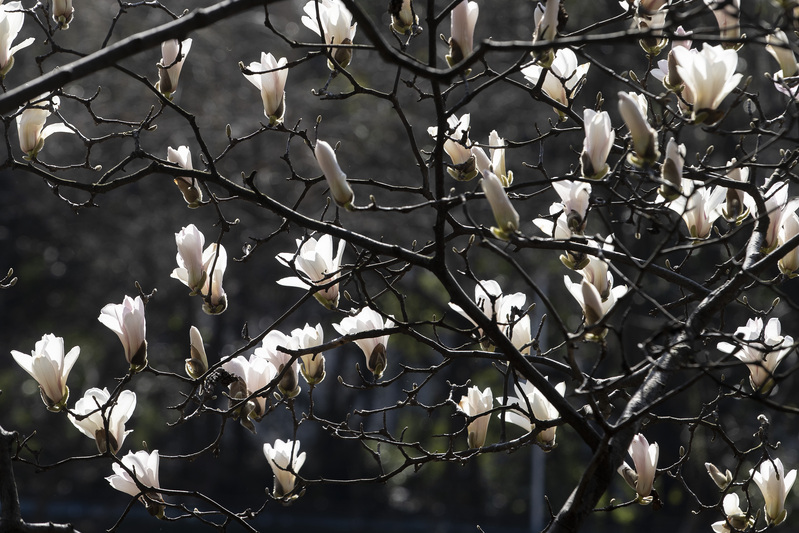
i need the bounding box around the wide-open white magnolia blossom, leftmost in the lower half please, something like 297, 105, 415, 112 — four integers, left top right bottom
11, 333, 80, 411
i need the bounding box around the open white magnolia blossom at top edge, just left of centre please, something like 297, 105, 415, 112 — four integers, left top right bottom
302, 0, 357, 69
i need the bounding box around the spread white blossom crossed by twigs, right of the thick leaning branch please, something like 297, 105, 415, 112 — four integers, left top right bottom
717, 317, 794, 394
